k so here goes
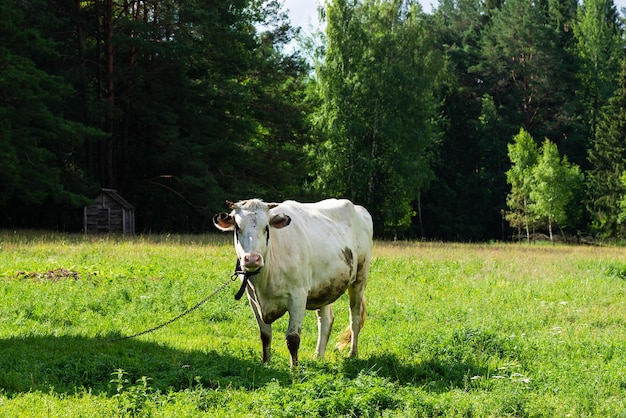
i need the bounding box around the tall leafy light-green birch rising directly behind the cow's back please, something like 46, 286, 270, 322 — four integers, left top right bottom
315, 0, 441, 234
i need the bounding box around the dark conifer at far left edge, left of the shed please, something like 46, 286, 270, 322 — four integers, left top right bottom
0, 1, 102, 224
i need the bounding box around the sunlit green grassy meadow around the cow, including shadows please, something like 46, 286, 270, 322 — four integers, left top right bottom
0, 231, 626, 417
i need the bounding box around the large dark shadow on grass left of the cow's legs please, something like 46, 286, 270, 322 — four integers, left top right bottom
0, 336, 290, 395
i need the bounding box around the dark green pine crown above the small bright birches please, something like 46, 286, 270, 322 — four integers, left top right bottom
471, 0, 575, 151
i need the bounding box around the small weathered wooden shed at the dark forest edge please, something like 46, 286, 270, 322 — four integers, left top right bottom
84, 189, 135, 234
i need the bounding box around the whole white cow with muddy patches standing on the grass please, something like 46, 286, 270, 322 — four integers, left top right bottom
213, 199, 373, 367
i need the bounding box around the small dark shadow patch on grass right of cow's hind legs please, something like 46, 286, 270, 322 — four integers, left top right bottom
343, 354, 487, 393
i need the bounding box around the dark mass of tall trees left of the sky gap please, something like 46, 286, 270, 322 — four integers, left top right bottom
0, 0, 308, 231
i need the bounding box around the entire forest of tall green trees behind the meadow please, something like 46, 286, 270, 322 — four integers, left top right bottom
0, 0, 626, 241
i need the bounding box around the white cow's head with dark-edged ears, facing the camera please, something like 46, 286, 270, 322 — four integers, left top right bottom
213, 199, 291, 272
